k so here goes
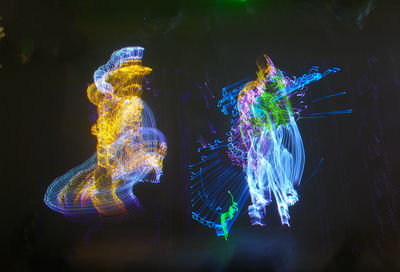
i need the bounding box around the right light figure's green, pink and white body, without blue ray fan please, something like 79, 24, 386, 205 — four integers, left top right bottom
231, 56, 306, 225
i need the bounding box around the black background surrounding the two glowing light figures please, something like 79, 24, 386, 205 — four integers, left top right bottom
0, 0, 400, 271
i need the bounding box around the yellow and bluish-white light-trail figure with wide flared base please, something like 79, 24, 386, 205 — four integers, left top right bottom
44, 47, 167, 221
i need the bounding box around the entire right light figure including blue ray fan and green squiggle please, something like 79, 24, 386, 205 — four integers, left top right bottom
190, 55, 351, 238
